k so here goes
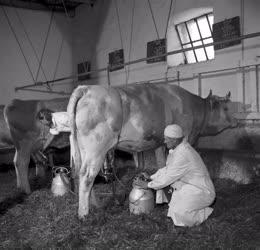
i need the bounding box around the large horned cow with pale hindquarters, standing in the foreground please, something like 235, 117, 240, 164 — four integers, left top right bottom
67, 83, 238, 218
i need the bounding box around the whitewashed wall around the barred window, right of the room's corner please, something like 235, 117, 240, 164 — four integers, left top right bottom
74, 0, 260, 112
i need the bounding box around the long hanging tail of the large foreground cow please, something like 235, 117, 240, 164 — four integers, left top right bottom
67, 86, 88, 175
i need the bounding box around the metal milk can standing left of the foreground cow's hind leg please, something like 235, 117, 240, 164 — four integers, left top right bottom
51, 166, 71, 196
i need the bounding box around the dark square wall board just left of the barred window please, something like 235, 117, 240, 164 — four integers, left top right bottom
146, 39, 166, 63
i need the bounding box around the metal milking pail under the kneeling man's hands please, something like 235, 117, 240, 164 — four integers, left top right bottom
129, 185, 154, 214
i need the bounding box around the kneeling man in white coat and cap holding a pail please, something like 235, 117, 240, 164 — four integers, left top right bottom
136, 124, 215, 227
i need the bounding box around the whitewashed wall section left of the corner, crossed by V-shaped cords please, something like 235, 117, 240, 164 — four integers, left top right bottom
0, 7, 73, 104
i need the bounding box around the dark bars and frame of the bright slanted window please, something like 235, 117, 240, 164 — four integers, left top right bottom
175, 12, 215, 64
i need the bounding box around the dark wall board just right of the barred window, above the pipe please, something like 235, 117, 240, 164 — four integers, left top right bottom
213, 16, 241, 50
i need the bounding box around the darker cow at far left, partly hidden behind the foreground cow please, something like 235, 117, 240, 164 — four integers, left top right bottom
4, 98, 69, 194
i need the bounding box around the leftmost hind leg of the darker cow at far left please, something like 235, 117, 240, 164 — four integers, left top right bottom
14, 148, 31, 194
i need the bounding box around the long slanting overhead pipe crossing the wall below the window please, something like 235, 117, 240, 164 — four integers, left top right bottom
15, 32, 260, 91
